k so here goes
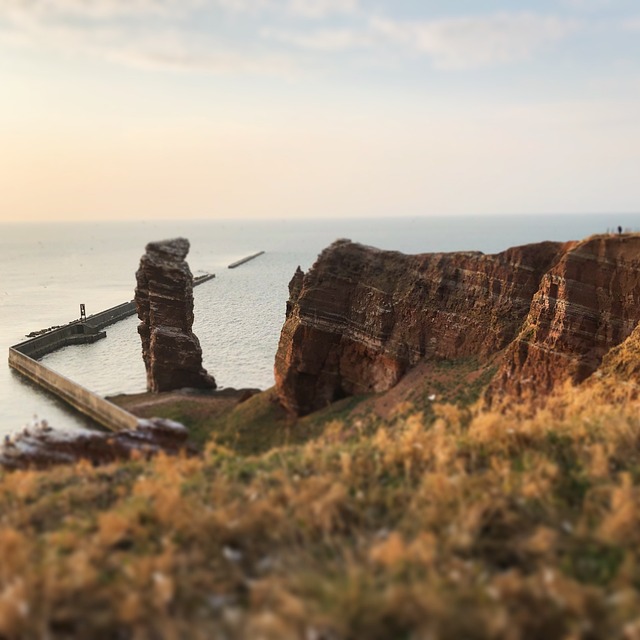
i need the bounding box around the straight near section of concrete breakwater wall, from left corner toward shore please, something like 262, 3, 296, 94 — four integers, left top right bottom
9, 345, 138, 431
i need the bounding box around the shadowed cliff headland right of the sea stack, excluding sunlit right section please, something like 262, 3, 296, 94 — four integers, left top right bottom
275, 240, 565, 415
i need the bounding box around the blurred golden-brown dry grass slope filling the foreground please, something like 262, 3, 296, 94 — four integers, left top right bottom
0, 372, 640, 640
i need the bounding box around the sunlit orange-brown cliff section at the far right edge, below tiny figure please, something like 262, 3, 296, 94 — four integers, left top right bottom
489, 234, 640, 397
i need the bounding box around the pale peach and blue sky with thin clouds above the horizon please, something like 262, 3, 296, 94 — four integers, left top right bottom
0, 0, 640, 222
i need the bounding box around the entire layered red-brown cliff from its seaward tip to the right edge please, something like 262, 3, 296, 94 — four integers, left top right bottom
275, 235, 640, 415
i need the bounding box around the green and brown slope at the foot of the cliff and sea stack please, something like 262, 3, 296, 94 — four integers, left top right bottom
110, 360, 495, 455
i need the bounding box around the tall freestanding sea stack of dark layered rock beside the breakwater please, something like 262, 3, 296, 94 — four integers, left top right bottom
135, 238, 216, 392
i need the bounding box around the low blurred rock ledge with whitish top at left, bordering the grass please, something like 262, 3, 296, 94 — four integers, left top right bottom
0, 418, 196, 469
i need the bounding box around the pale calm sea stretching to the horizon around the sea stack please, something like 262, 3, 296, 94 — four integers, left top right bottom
0, 214, 640, 435
